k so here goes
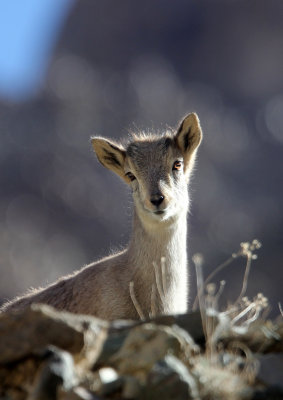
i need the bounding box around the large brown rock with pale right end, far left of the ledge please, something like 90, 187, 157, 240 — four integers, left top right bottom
0, 305, 109, 364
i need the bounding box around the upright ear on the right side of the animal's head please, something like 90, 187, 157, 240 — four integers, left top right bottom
175, 113, 202, 169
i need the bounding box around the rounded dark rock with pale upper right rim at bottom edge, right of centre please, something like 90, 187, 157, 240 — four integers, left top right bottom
141, 355, 199, 400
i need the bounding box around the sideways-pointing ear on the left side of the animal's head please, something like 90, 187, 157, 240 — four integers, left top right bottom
91, 137, 128, 183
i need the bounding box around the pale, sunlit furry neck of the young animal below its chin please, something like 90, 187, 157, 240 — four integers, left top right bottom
127, 209, 188, 316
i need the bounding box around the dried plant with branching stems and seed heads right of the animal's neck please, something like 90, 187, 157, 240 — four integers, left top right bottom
192, 239, 268, 390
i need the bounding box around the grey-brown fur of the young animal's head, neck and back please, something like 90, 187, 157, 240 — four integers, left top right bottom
1, 114, 202, 320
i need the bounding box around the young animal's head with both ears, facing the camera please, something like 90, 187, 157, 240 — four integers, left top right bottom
92, 113, 202, 222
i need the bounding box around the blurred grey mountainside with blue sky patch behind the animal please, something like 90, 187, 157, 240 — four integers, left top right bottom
0, 0, 283, 315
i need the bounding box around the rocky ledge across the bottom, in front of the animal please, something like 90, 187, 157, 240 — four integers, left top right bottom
0, 305, 283, 400
